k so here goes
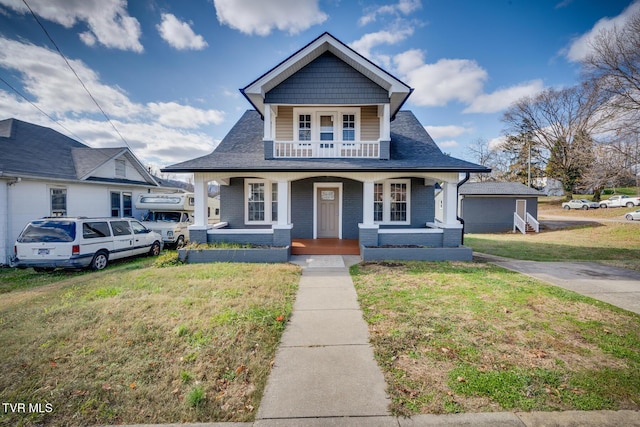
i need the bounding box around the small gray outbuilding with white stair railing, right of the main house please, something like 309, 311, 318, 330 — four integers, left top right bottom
458, 182, 544, 233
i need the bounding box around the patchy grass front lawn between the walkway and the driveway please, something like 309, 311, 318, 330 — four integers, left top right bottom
351, 262, 640, 415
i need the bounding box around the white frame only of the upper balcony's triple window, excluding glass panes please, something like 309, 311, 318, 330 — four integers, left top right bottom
293, 106, 360, 146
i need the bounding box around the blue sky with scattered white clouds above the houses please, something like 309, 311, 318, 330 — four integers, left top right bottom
0, 0, 640, 176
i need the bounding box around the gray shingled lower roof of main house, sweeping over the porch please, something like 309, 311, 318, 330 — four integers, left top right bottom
163, 110, 490, 172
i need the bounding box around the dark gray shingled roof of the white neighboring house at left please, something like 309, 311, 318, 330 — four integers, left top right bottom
0, 119, 158, 186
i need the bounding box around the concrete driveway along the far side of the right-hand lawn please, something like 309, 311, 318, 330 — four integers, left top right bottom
473, 252, 640, 314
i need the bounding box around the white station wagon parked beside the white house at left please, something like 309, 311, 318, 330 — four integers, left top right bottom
11, 217, 163, 271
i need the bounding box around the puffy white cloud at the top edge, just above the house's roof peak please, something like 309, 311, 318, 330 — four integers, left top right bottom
213, 0, 328, 36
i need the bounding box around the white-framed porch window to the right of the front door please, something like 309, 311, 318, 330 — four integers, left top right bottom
373, 179, 411, 224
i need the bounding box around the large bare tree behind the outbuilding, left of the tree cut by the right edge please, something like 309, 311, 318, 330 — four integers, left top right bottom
502, 81, 610, 198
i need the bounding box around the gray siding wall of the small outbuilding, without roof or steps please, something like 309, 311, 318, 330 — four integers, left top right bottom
461, 196, 538, 233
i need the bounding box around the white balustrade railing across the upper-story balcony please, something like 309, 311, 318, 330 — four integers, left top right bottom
273, 141, 380, 159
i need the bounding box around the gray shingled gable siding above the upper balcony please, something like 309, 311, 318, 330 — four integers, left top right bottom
264, 52, 389, 105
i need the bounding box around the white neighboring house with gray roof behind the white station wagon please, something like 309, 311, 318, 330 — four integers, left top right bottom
0, 119, 167, 265
